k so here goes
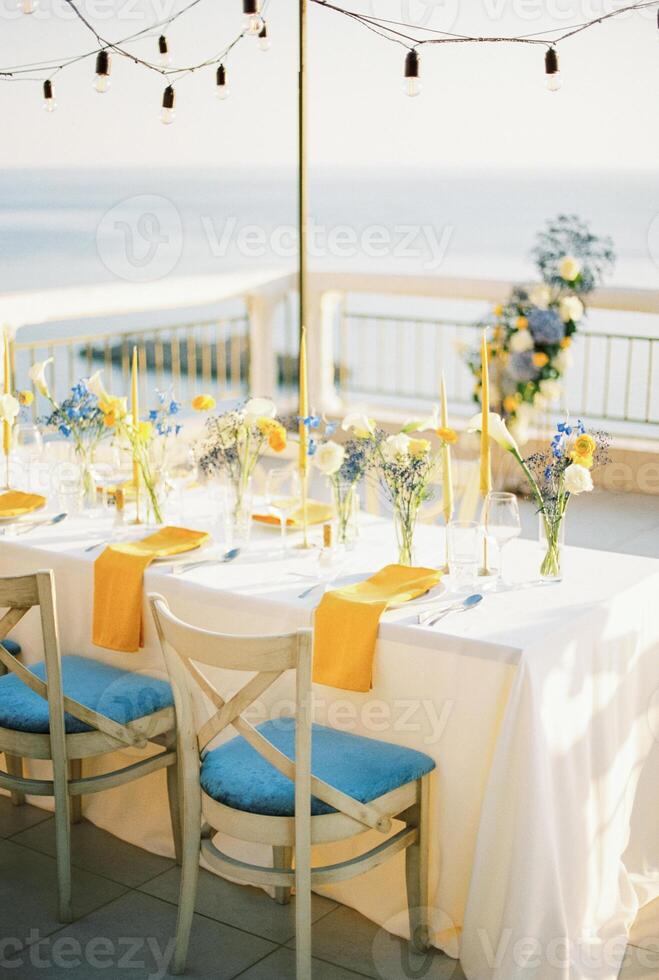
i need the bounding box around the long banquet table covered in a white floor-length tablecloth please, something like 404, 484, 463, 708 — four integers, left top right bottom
0, 504, 659, 980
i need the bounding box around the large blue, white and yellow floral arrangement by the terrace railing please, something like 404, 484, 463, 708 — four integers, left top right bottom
466, 215, 615, 443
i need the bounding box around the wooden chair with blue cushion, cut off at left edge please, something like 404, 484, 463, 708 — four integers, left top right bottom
0, 571, 181, 922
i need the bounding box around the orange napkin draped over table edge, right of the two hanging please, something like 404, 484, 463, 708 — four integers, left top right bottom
313, 565, 442, 691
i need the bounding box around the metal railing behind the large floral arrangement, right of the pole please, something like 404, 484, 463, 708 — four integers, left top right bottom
335, 310, 659, 435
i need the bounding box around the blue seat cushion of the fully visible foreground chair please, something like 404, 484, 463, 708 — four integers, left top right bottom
201, 718, 435, 817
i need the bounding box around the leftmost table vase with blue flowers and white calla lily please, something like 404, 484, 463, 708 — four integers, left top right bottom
29, 357, 108, 501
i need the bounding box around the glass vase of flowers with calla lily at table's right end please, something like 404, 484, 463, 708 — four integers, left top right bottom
469, 412, 611, 582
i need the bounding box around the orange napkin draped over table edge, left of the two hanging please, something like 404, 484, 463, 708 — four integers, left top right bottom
92, 527, 209, 653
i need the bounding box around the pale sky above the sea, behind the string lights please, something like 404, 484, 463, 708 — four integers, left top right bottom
0, 0, 659, 170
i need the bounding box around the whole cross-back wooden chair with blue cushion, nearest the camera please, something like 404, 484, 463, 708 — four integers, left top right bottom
150, 595, 435, 980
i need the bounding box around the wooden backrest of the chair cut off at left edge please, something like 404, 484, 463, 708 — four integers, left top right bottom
0, 571, 146, 758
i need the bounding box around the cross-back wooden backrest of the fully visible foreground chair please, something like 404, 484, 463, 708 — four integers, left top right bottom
149, 595, 391, 831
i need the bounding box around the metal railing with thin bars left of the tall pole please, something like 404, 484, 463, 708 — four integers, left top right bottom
13, 314, 250, 418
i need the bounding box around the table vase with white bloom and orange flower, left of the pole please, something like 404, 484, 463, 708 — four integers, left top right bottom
196, 398, 286, 536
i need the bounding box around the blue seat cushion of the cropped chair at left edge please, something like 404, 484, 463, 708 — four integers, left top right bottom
0, 657, 174, 735
